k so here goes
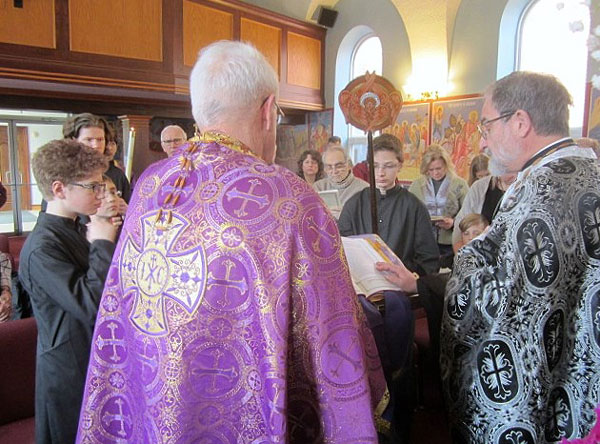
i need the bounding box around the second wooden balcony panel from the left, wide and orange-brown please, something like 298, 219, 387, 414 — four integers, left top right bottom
69, 0, 163, 62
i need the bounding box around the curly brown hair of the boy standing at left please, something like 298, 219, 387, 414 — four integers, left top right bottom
31, 139, 108, 200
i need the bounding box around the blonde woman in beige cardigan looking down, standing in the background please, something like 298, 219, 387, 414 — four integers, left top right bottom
408, 145, 469, 267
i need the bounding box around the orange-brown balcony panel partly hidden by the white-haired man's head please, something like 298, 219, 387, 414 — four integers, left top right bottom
183, 0, 233, 66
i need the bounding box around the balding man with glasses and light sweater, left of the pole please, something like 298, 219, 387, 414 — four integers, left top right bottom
313, 145, 369, 219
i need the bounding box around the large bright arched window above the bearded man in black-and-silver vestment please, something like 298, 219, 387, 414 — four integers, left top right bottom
516, 0, 590, 137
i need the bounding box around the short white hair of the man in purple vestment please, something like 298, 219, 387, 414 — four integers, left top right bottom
190, 40, 279, 128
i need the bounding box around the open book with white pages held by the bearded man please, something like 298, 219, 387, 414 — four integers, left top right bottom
342, 234, 401, 297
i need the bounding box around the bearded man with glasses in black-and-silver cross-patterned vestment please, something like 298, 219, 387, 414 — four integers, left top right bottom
441, 72, 600, 444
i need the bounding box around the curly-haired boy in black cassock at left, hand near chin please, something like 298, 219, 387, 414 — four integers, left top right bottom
19, 140, 117, 444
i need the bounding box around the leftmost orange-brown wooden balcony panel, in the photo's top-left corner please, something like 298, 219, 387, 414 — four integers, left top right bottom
0, 0, 56, 48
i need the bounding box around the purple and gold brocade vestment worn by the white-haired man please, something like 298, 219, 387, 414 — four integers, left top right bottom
77, 137, 386, 444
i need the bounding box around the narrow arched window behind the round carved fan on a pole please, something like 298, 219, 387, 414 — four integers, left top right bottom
348, 34, 383, 162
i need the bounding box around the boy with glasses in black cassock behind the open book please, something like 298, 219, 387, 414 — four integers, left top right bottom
338, 134, 440, 275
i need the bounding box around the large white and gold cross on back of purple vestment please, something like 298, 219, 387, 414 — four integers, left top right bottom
120, 212, 206, 335
